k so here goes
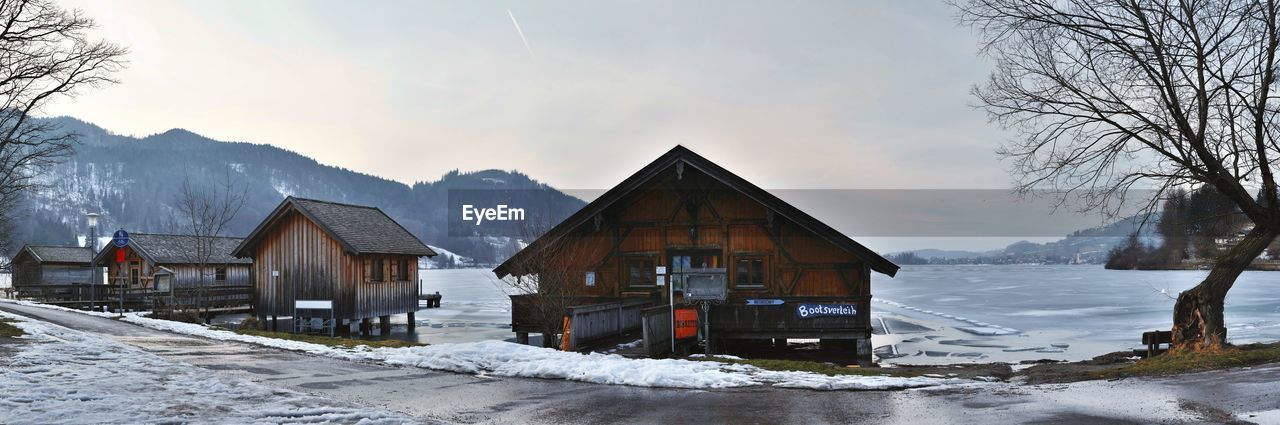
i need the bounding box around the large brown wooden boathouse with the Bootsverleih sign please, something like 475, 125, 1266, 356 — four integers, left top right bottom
494, 146, 899, 362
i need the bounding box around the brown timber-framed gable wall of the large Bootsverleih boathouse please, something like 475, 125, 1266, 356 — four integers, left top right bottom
527, 169, 870, 333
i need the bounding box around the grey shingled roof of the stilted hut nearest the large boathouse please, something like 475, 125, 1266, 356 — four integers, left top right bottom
233, 196, 435, 257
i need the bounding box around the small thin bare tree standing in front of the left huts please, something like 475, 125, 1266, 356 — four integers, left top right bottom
174, 170, 248, 323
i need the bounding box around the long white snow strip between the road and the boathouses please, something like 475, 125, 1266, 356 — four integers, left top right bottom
4, 301, 972, 389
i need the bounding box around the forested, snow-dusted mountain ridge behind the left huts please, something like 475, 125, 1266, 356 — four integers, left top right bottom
15, 118, 585, 264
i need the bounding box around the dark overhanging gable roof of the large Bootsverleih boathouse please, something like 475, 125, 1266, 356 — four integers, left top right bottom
493, 145, 899, 278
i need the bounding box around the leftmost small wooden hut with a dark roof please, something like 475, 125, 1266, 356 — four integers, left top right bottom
10, 245, 102, 298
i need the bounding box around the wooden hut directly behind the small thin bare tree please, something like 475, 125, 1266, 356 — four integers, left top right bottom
93, 233, 253, 311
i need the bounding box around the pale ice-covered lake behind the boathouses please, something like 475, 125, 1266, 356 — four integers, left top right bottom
393, 265, 1280, 364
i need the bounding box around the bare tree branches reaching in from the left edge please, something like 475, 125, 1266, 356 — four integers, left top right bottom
0, 0, 125, 252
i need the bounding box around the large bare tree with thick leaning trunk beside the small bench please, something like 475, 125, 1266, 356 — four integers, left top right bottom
954, 0, 1280, 351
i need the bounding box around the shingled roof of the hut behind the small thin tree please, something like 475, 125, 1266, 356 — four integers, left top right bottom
93, 233, 253, 264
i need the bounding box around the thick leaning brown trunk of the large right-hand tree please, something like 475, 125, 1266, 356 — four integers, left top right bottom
1170, 225, 1276, 353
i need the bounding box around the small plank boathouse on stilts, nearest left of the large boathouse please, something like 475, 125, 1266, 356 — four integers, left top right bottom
227, 196, 435, 333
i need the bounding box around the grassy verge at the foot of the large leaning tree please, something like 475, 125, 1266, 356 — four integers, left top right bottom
1097, 344, 1280, 379
